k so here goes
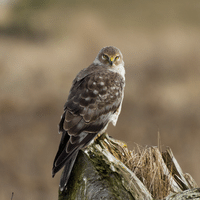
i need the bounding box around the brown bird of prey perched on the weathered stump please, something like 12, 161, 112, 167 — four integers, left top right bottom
52, 46, 125, 191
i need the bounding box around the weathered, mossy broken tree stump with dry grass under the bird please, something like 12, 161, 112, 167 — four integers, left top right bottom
59, 134, 200, 200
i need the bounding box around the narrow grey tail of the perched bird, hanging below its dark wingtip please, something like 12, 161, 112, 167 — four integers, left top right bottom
60, 151, 79, 191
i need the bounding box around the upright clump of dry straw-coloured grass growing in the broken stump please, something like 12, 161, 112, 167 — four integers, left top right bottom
127, 146, 171, 199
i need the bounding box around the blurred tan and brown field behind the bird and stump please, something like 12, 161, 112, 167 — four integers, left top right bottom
0, 0, 200, 200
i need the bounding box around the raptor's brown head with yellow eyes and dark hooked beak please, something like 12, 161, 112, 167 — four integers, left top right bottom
94, 46, 124, 68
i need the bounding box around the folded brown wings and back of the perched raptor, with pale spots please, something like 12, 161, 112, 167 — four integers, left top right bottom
53, 67, 124, 175
